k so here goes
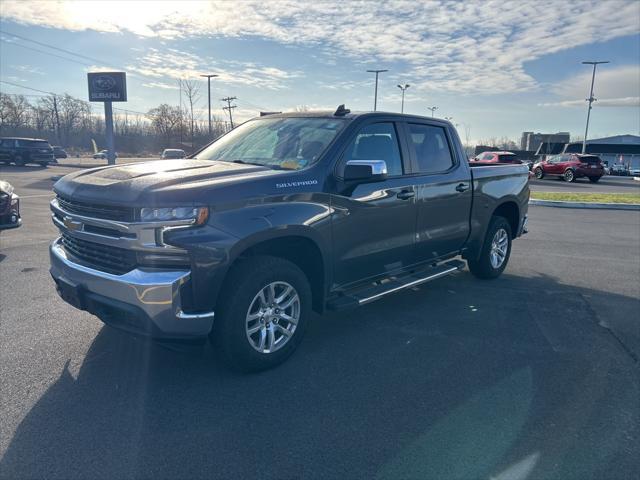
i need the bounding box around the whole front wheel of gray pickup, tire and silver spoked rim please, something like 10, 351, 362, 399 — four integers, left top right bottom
211, 256, 311, 372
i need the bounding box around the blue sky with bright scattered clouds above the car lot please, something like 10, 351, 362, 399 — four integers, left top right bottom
0, 0, 640, 141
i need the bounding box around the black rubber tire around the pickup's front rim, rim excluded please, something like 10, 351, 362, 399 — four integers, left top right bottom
211, 256, 311, 372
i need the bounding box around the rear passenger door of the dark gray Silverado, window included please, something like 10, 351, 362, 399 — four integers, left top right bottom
403, 121, 473, 262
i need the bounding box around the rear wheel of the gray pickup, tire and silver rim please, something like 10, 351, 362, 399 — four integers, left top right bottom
467, 216, 512, 279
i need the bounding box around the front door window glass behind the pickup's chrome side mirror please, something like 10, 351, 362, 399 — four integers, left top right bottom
341, 123, 402, 177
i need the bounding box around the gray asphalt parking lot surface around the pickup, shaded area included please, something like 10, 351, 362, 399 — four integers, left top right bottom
0, 166, 640, 479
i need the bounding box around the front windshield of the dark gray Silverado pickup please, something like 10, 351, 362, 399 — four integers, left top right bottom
194, 117, 344, 170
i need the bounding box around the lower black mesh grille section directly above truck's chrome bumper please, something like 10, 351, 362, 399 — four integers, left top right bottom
62, 233, 136, 275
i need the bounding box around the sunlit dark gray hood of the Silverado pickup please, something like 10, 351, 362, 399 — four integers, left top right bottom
53, 160, 284, 206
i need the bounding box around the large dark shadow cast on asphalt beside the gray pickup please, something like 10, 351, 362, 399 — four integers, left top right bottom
0, 273, 640, 479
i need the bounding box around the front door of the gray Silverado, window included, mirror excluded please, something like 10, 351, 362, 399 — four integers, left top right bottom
331, 122, 416, 286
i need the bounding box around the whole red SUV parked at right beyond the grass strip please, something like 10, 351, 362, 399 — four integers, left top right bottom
533, 153, 604, 183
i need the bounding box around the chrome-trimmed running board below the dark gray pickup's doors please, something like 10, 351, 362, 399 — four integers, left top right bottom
327, 260, 465, 310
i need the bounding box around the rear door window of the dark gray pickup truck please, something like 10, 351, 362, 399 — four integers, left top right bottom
408, 123, 452, 173
